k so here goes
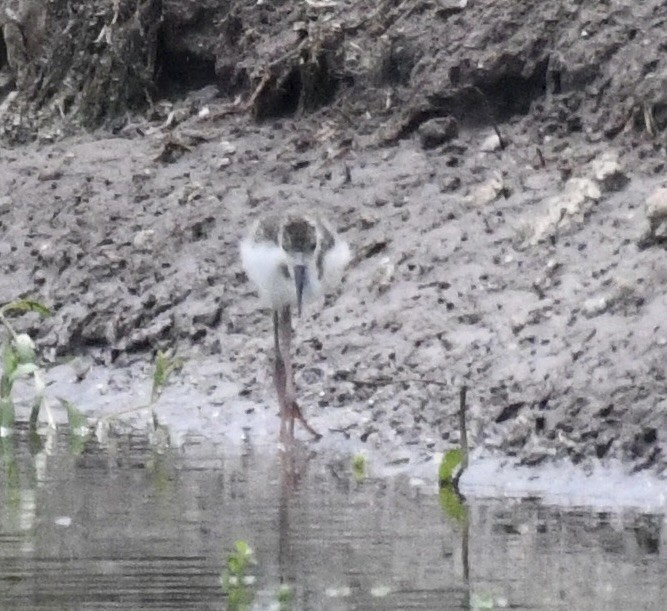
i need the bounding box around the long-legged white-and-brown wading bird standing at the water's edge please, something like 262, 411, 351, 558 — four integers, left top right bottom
240, 210, 351, 440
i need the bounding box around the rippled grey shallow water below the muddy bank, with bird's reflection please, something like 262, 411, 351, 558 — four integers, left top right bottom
0, 433, 667, 610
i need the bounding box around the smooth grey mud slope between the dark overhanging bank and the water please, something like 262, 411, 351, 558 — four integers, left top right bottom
1, 123, 665, 473
